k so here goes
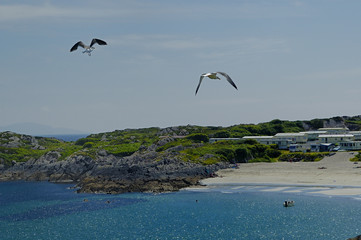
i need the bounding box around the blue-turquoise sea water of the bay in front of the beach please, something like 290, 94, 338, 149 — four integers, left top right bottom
0, 182, 361, 239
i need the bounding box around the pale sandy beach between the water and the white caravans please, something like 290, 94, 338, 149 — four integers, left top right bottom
201, 152, 361, 196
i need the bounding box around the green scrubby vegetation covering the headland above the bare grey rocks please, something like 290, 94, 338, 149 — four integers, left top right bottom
0, 116, 361, 165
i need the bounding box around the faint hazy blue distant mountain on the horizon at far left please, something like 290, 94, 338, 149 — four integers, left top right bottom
0, 122, 87, 136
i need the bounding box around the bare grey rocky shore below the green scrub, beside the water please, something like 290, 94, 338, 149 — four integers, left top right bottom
0, 143, 228, 193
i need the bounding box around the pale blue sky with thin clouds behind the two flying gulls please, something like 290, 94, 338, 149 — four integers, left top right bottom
0, 0, 361, 133
